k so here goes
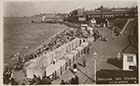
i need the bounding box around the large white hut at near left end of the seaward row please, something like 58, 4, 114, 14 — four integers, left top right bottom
26, 53, 51, 78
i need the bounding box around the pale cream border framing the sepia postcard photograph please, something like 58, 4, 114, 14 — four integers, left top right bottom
0, 0, 140, 86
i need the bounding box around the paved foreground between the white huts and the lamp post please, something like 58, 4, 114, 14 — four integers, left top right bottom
52, 43, 95, 84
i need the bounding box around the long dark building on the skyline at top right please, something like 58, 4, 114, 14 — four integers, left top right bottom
85, 6, 138, 19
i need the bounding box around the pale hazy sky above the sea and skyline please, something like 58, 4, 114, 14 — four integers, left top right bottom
3, 0, 137, 17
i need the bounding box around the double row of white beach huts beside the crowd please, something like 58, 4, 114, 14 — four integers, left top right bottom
25, 38, 89, 80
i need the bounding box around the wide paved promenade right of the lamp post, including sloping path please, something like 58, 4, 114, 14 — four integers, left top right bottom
94, 21, 134, 71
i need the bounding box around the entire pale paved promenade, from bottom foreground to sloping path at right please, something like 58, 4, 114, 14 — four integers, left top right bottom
53, 21, 136, 84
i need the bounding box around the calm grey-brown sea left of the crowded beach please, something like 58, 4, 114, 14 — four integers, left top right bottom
3, 17, 69, 64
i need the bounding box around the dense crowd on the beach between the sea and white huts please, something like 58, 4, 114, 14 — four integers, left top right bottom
4, 24, 99, 84
